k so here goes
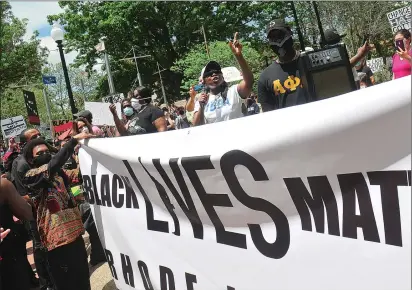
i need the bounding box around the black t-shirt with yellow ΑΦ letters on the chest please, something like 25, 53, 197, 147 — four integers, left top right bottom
258, 59, 308, 112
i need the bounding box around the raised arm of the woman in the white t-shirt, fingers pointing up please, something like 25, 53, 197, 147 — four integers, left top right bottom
229, 32, 253, 99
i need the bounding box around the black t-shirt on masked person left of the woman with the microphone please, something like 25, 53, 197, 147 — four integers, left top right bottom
127, 105, 163, 135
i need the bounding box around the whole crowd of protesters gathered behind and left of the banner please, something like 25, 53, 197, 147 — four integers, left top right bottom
0, 20, 412, 290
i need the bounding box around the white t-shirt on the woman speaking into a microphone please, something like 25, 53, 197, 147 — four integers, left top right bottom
194, 84, 242, 124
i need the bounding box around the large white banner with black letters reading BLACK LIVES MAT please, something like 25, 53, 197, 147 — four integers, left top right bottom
80, 77, 411, 290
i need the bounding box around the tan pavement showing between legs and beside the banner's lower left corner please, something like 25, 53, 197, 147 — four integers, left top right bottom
26, 234, 117, 290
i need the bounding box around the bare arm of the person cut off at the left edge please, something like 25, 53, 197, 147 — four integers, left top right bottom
0, 178, 33, 221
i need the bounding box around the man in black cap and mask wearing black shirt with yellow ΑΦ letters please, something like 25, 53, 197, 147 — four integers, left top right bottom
258, 19, 308, 112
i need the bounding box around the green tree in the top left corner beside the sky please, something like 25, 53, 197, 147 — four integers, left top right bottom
0, 1, 47, 92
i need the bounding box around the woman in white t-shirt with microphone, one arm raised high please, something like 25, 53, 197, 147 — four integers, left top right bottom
193, 32, 253, 126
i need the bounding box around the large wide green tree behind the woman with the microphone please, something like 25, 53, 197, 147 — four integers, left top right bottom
45, 1, 283, 100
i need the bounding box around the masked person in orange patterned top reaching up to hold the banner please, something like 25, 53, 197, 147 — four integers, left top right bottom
23, 132, 94, 290
